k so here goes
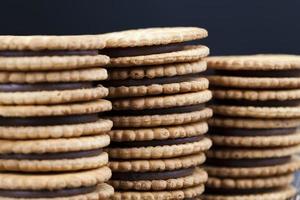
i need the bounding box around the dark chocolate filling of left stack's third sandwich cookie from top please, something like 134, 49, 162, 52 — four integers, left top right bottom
0, 114, 99, 126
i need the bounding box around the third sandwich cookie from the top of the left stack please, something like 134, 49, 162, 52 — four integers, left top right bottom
0, 99, 112, 139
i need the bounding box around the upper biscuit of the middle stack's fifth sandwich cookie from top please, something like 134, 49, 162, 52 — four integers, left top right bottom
109, 152, 206, 172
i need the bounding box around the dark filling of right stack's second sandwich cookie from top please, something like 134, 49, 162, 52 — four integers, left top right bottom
214, 99, 300, 107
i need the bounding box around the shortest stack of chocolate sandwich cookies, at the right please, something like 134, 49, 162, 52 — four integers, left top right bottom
203, 55, 300, 200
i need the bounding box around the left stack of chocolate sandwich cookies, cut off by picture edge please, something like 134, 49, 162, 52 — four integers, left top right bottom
0, 36, 113, 200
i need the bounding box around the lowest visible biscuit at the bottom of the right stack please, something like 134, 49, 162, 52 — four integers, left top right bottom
201, 186, 296, 200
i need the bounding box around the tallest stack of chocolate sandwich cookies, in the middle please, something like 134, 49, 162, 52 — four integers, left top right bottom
101, 28, 212, 200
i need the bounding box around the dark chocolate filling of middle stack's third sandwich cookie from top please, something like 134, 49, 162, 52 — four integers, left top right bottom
107, 104, 205, 116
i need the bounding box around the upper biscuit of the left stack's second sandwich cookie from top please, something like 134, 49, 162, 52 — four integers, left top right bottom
0, 68, 108, 83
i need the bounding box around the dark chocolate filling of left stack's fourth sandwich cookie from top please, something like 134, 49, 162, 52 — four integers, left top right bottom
0, 149, 102, 160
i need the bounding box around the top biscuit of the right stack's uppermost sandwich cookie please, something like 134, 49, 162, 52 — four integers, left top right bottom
206, 55, 300, 70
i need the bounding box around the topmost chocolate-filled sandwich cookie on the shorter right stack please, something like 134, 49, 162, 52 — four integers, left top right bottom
207, 55, 300, 89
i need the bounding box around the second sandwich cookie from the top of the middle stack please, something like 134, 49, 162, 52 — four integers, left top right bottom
104, 61, 208, 98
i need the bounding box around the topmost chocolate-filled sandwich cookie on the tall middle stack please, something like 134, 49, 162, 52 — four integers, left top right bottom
100, 27, 209, 67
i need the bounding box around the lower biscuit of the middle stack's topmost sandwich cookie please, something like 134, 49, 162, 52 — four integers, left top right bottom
109, 45, 209, 67
